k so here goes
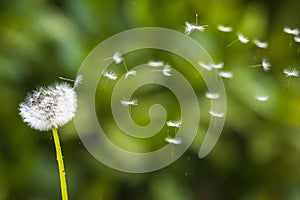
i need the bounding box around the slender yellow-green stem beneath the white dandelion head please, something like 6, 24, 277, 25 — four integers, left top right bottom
52, 127, 68, 200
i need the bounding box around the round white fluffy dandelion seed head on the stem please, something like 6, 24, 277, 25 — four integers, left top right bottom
19, 83, 77, 131
